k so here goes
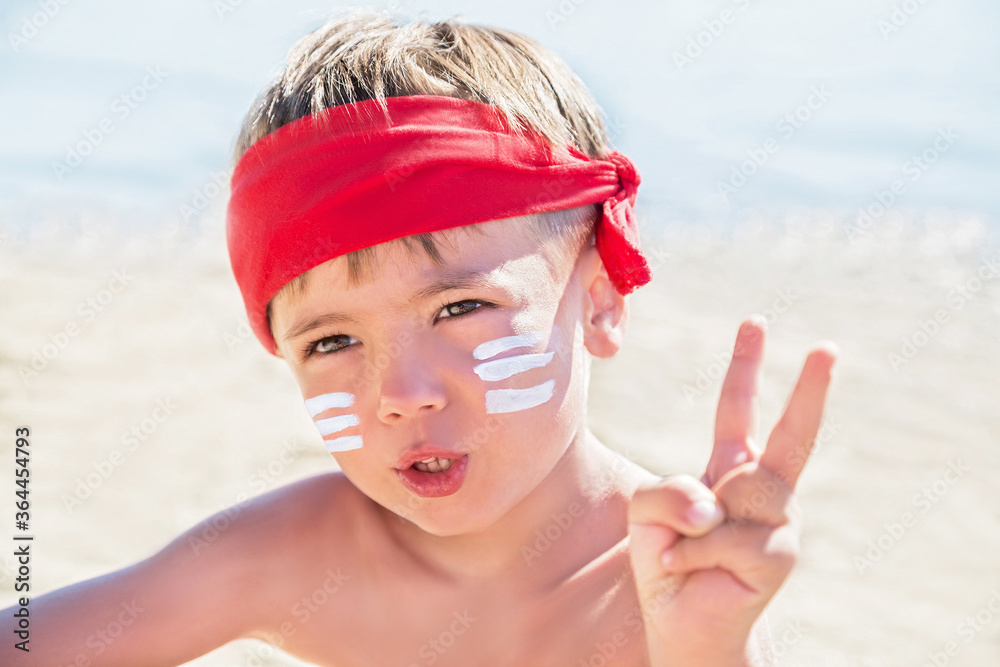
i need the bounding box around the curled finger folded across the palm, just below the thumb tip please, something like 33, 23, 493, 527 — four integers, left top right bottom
661, 524, 799, 595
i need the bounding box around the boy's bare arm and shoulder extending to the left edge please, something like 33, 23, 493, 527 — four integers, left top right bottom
0, 480, 340, 667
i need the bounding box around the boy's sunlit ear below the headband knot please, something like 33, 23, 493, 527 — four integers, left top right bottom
578, 245, 628, 358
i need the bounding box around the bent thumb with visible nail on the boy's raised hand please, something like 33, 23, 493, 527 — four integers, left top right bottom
628, 475, 725, 535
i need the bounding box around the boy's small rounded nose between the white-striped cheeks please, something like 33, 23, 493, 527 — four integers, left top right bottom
377, 349, 447, 424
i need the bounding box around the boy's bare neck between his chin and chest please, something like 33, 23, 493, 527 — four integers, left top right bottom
382, 434, 653, 591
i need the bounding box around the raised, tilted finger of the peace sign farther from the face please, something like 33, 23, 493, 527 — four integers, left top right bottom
760, 342, 837, 489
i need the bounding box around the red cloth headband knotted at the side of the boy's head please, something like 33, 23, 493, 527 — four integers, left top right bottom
226, 95, 650, 354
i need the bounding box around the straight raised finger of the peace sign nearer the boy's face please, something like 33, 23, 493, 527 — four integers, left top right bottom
705, 315, 767, 486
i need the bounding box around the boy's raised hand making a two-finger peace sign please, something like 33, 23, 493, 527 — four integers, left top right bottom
629, 318, 836, 667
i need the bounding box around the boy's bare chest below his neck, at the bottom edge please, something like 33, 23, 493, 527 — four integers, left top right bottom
283, 569, 647, 667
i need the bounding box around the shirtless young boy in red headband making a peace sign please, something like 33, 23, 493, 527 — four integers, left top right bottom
3, 7, 834, 666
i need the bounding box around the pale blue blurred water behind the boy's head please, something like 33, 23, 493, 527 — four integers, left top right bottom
0, 0, 1000, 240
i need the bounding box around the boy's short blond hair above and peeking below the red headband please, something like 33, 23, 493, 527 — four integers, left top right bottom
234, 9, 610, 319
